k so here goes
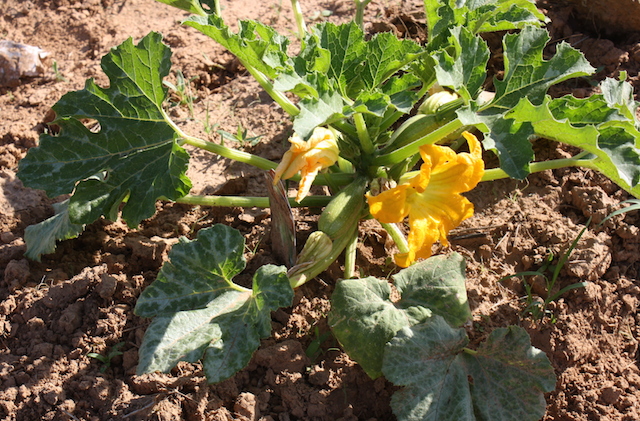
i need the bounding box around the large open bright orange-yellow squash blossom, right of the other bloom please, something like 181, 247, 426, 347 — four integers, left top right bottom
367, 132, 484, 267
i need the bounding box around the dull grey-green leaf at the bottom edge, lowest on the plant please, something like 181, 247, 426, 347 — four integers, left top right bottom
383, 316, 555, 421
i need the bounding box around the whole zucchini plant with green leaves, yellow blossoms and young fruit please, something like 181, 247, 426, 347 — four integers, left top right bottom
18, 0, 640, 421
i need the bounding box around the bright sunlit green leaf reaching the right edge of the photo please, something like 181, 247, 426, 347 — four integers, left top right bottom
506, 96, 640, 197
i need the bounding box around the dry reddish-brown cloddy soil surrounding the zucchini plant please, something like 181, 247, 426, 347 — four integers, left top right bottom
0, 0, 640, 421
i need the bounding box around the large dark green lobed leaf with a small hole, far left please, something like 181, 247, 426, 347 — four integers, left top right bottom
18, 33, 191, 226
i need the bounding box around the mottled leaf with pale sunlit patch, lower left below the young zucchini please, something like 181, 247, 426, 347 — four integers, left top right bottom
135, 225, 293, 383
